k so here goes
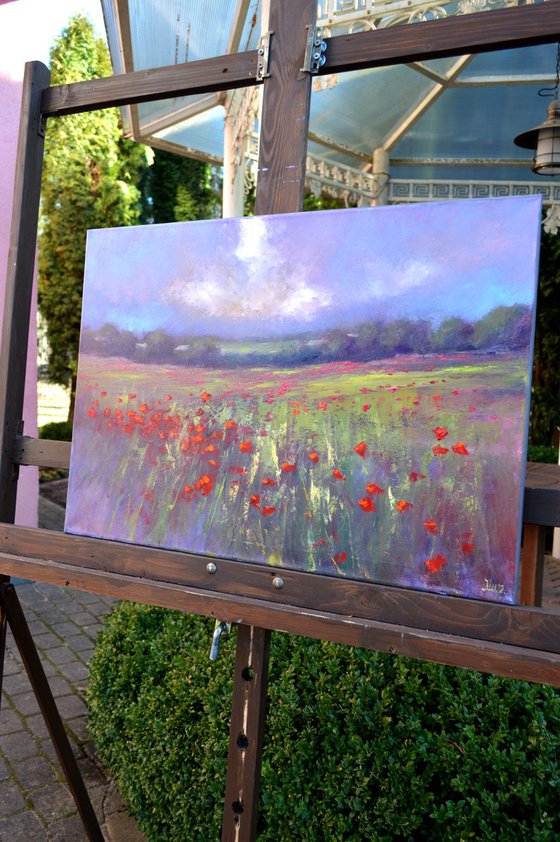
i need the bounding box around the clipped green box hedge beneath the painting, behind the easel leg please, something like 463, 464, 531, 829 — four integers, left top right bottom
89, 603, 560, 842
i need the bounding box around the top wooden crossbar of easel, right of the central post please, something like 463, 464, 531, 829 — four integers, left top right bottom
319, 0, 560, 76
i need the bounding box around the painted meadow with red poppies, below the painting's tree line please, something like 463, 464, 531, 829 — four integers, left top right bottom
67, 355, 527, 600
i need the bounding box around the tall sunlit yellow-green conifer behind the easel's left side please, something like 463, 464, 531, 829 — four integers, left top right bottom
39, 15, 146, 404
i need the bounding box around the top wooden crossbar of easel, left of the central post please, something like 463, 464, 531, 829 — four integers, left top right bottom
41, 50, 258, 117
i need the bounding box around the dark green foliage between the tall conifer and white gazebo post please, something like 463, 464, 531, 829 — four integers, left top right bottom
142, 149, 217, 222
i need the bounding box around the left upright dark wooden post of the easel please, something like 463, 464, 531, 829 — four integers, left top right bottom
0, 62, 50, 521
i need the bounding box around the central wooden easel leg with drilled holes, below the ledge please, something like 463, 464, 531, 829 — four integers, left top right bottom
222, 625, 270, 842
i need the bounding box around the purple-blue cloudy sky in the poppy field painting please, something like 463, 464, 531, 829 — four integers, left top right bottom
83, 197, 540, 339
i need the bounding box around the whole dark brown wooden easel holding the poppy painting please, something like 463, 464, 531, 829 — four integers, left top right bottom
0, 0, 560, 842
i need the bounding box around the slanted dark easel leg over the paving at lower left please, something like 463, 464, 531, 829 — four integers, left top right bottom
0, 583, 103, 842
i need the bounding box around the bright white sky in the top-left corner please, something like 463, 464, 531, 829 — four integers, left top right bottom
0, 0, 106, 79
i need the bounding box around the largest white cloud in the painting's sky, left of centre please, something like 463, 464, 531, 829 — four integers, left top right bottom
162, 218, 332, 321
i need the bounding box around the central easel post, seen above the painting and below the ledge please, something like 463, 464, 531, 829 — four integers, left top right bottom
222, 0, 317, 842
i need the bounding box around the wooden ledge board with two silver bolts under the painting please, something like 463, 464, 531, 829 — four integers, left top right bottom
0, 524, 560, 653
